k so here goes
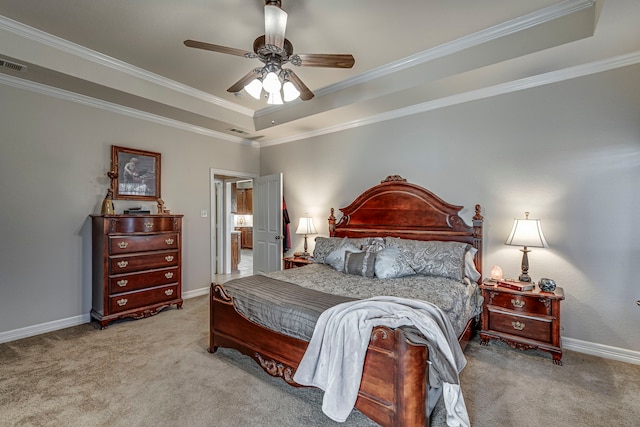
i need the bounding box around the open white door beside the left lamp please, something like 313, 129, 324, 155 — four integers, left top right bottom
253, 173, 283, 274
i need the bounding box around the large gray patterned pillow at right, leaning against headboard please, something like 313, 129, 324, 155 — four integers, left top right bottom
387, 237, 471, 282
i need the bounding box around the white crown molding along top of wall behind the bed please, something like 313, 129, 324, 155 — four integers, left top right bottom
260, 50, 640, 148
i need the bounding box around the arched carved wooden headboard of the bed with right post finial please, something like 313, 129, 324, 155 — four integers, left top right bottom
329, 175, 483, 273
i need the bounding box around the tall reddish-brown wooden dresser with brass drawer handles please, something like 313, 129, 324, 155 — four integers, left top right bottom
91, 214, 183, 329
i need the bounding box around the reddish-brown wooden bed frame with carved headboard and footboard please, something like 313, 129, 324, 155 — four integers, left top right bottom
209, 176, 483, 427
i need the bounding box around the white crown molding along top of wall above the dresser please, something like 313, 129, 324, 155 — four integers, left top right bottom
0, 74, 257, 146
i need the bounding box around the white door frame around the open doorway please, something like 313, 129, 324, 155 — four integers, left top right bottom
209, 168, 259, 282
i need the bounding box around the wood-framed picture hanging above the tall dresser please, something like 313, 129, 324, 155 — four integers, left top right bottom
111, 145, 161, 201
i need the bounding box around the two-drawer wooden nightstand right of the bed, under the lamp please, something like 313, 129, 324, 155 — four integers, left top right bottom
480, 281, 564, 365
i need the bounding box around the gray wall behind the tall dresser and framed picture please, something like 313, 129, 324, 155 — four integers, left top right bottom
0, 85, 259, 333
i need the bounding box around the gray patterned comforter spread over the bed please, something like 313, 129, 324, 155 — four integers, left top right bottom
222, 264, 482, 341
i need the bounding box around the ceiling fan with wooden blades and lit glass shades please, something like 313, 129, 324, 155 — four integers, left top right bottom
184, 0, 355, 104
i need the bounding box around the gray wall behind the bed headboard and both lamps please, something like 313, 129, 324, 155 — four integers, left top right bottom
260, 65, 640, 351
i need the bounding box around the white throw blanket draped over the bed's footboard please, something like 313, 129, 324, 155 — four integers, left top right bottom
293, 296, 470, 426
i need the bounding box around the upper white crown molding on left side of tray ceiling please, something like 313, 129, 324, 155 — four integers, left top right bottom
0, 15, 253, 117
